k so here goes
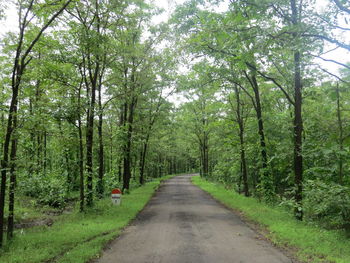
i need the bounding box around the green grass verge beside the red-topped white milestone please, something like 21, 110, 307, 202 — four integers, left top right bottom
0, 176, 174, 263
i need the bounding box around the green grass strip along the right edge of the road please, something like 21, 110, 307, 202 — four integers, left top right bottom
192, 176, 350, 263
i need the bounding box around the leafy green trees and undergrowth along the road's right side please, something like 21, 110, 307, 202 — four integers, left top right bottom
170, 0, 350, 243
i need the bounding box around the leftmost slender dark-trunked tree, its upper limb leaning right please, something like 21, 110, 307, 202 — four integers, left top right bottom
0, 0, 72, 247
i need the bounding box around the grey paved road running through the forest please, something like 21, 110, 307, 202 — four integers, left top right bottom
98, 175, 292, 263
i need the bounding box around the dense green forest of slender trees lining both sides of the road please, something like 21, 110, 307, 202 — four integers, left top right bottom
0, 0, 350, 252
